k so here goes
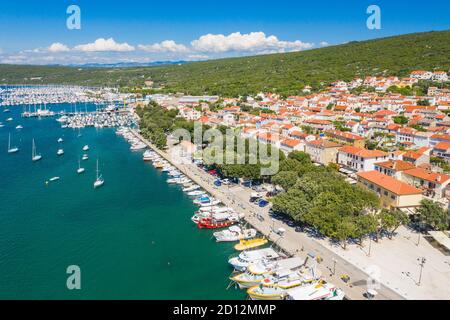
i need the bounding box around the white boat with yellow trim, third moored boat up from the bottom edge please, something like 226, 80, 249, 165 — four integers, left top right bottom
230, 257, 305, 289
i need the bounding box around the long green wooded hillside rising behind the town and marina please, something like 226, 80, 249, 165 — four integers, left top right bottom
0, 30, 450, 96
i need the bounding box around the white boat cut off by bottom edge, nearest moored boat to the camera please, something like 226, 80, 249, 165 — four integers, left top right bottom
285, 280, 345, 300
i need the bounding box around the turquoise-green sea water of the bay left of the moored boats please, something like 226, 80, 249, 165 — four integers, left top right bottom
0, 105, 245, 299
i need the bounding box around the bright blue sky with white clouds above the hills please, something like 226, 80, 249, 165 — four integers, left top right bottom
0, 0, 450, 63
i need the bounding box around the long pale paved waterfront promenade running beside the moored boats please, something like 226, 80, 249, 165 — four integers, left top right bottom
132, 130, 405, 300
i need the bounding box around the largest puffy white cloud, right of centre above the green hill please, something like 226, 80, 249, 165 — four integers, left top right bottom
191, 32, 314, 53
